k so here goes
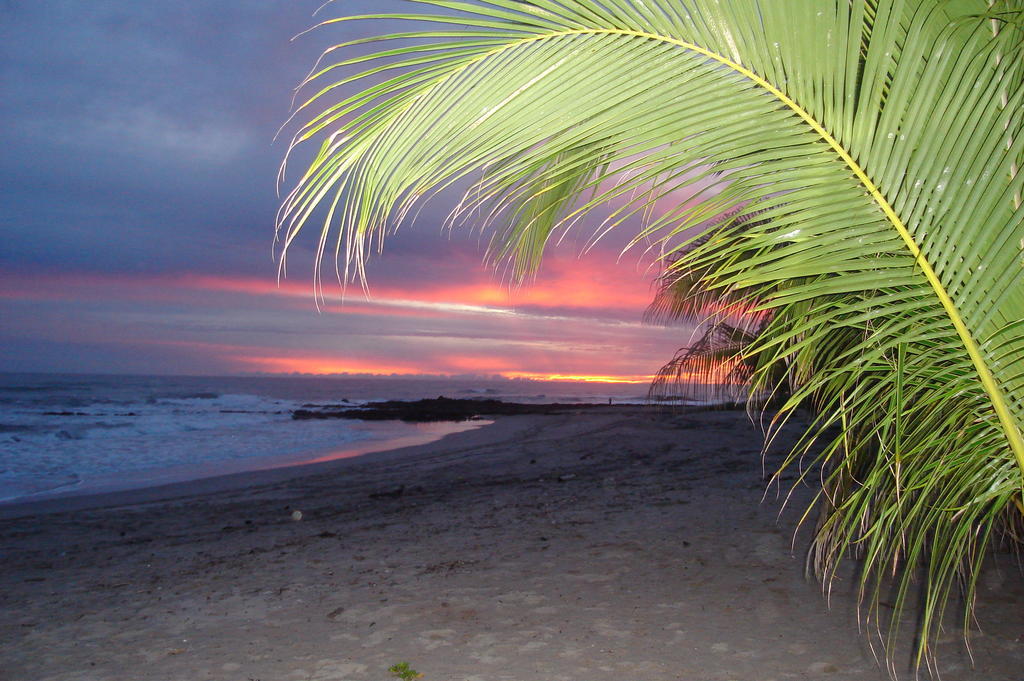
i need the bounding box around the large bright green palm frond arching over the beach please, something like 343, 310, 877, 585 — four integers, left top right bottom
280, 0, 1024, 659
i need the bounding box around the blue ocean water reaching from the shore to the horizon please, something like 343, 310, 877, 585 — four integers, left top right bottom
0, 373, 646, 504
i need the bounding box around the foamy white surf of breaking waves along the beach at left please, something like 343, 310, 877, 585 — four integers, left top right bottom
0, 387, 371, 500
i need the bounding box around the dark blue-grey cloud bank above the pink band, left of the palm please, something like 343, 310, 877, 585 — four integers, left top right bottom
0, 0, 456, 275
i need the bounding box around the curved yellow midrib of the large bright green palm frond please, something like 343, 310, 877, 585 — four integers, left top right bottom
374, 21, 1024, 472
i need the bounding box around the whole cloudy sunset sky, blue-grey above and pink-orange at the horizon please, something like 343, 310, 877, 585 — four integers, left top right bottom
0, 0, 689, 379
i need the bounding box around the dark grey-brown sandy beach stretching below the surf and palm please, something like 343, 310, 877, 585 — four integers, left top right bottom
0, 408, 1024, 681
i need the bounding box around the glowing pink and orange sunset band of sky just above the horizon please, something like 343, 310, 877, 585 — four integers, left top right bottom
0, 254, 675, 384
